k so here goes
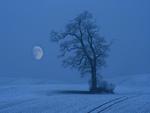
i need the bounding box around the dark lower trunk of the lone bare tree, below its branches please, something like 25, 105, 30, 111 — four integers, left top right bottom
91, 63, 97, 91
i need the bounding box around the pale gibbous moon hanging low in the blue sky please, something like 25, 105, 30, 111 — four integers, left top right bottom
33, 46, 44, 60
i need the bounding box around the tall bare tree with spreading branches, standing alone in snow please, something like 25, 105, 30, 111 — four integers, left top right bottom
51, 11, 109, 91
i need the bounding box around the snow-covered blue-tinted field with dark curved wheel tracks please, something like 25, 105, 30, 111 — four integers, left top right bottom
0, 75, 150, 113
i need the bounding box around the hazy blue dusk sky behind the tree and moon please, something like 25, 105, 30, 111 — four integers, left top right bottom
0, 0, 150, 81
